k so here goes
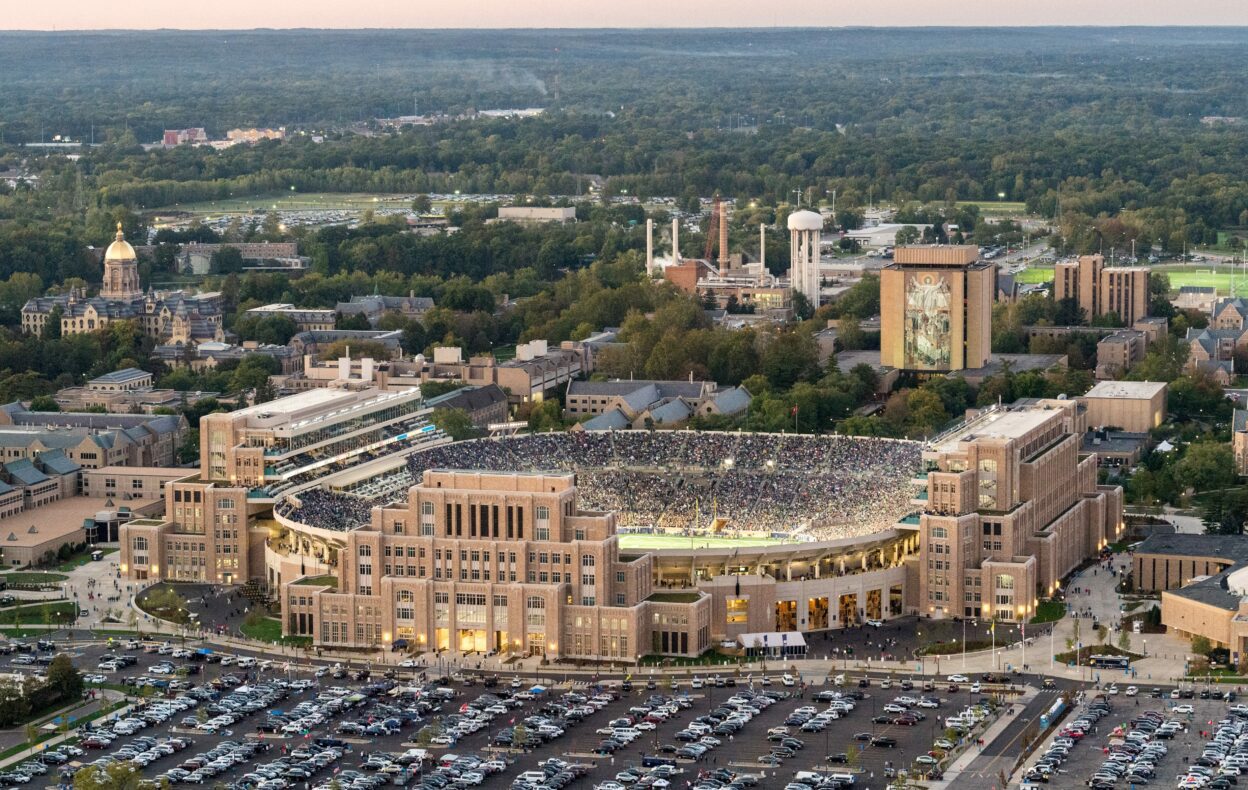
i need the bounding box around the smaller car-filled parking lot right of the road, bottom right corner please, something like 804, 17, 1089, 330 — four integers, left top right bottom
1025, 684, 1248, 789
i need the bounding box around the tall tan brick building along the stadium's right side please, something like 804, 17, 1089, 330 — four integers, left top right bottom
919, 401, 1123, 622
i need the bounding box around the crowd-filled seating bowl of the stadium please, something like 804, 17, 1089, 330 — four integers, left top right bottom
278, 431, 921, 540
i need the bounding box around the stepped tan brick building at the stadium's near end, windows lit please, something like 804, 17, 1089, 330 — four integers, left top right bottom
282, 471, 710, 661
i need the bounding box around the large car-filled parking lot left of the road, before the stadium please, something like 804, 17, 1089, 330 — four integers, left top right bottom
0, 641, 1028, 790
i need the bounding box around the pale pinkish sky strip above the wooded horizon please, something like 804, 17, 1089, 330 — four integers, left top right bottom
7, 0, 1248, 30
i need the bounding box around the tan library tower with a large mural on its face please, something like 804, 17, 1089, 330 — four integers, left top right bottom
880, 245, 996, 373
